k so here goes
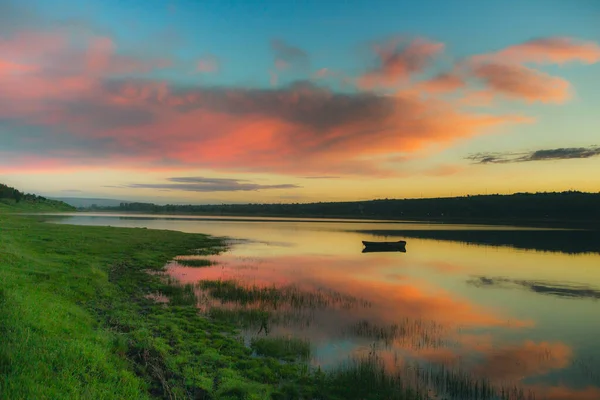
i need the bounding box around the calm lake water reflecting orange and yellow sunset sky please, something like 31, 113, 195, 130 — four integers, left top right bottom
52, 214, 600, 400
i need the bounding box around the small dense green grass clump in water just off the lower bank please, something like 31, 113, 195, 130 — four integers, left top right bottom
250, 336, 311, 362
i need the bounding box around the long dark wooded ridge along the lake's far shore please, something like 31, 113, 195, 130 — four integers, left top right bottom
103, 191, 600, 222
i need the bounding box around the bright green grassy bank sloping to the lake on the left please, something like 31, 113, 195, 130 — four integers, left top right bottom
0, 213, 288, 399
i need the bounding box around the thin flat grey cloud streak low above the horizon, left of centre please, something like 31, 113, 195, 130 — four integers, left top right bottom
121, 177, 301, 192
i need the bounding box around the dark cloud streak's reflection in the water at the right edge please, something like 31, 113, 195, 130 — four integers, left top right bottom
467, 276, 600, 299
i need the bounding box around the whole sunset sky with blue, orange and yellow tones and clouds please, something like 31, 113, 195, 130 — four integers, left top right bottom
0, 0, 600, 204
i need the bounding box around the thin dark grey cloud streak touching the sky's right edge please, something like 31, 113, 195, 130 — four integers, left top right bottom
466, 146, 600, 164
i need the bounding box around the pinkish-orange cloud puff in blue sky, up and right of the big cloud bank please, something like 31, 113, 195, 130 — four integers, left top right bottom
358, 38, 444, 89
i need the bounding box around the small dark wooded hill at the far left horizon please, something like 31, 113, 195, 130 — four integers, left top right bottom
0, 183, 75, 213
